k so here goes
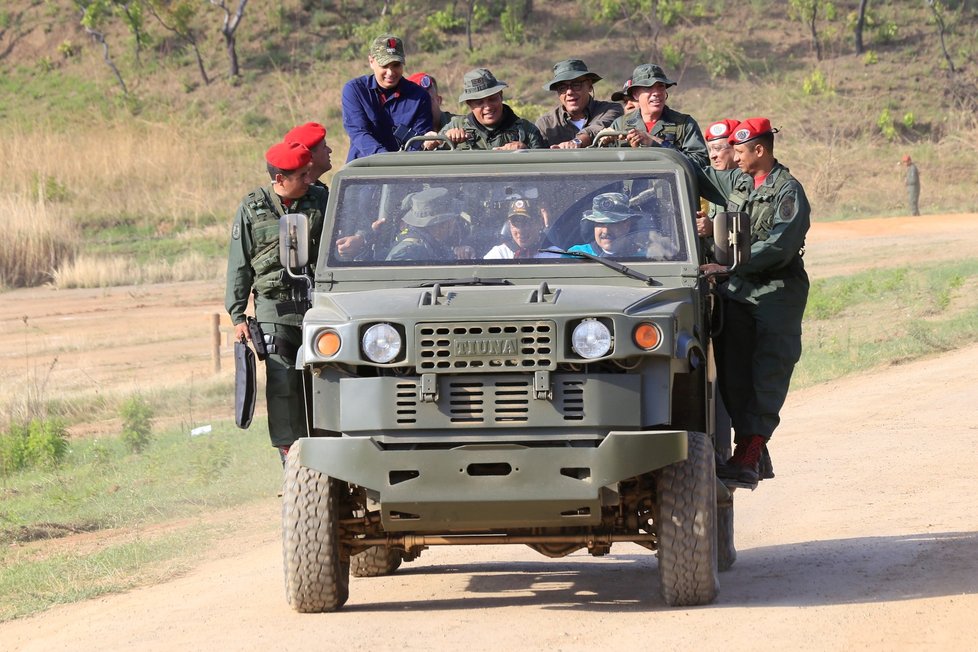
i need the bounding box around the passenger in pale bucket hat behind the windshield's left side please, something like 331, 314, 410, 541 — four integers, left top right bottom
387, 188, 475, 264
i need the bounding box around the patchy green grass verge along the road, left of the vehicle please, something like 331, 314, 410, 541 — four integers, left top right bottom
0, 422, 281, 622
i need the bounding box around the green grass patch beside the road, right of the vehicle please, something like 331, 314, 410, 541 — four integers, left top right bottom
792, 258, 978, 387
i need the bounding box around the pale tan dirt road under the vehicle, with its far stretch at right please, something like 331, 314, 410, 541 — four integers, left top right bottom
0, 216, 978, 652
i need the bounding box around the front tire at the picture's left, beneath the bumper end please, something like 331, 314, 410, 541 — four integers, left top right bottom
282, 440, 352, 613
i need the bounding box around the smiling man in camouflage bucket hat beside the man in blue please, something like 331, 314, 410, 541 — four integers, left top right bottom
425, 68, 545, 149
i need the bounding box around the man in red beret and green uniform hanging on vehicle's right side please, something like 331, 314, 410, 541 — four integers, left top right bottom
699, 118, 811, 484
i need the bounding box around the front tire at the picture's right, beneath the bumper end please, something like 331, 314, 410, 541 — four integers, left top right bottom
656, 432, 720, 607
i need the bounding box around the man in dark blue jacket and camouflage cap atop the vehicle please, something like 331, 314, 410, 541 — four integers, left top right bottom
343, 34, 432, 162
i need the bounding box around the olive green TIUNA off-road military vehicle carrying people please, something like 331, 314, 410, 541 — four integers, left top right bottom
281, 149, 744, 612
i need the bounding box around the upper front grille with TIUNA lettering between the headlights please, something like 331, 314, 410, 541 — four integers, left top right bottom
415, 321, 556, 373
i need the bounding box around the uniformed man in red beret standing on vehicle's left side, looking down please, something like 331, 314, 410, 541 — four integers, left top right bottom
224, 140, 329, 460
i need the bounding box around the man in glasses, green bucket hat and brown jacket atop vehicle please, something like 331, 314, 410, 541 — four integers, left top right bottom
536, 59, 624, 149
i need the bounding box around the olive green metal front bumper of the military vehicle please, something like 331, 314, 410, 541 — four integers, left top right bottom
297, 430, 687, 532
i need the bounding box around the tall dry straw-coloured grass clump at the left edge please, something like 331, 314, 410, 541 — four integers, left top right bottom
0, 192, 78, 287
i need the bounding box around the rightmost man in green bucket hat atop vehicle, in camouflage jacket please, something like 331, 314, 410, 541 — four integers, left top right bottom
611, 63, 709, 167
